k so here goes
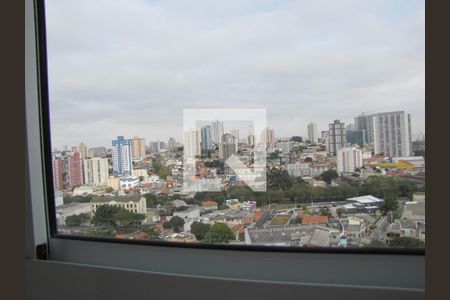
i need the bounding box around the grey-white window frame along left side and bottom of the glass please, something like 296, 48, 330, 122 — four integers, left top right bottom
25, 0, 425, 296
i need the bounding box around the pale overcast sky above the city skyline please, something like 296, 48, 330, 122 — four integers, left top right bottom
46, 0, 425, 148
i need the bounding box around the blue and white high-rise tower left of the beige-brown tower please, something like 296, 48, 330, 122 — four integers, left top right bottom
112, 136, 133, 176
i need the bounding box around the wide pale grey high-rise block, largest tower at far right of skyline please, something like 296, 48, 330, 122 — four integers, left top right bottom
372, 111, 412, 157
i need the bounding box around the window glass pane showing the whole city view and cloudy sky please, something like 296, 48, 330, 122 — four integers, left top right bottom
46, 0, 426, 248
